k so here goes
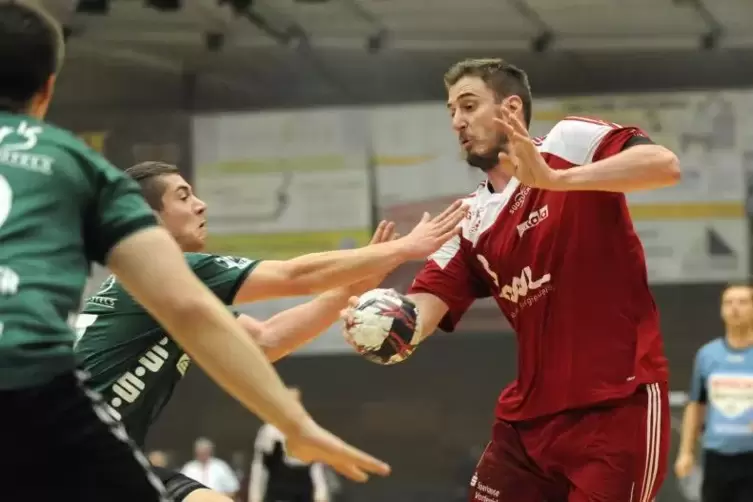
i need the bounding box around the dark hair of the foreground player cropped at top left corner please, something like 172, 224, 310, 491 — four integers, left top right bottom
0, 1, 65, 113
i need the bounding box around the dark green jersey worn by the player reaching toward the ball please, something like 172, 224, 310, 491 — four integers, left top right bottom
76, 253, 258, 444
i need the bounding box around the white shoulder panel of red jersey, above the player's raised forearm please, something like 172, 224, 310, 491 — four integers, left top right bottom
534, 117, 619, 165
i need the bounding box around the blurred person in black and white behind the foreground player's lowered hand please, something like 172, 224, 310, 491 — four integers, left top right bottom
248, 387, 331, 502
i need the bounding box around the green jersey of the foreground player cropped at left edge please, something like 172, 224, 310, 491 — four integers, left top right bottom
0, 113, 156, 389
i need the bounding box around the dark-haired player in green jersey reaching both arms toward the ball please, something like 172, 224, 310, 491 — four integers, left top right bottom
76, 162, 464, 502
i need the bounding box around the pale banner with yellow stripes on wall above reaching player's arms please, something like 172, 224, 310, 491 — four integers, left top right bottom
193, 109, 371, 259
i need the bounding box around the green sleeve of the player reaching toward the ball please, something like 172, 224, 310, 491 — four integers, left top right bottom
186, 253, 260, 305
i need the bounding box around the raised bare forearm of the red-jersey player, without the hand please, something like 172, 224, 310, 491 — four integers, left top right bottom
555, 145, 680, 192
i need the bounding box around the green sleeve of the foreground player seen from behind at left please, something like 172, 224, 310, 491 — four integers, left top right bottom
85, 151, 157, 265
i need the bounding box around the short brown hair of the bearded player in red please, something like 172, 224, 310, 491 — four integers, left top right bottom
444, 58, 533, 126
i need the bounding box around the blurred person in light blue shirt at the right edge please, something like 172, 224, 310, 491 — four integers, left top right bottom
675, 284, 753, 502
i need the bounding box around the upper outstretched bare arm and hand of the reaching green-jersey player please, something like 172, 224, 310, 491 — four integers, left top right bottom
234, 201, 465, 304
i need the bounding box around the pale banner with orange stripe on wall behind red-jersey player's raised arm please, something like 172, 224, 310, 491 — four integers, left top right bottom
534, 91, 753, 284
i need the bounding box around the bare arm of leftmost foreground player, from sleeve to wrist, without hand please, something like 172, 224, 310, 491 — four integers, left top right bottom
107, 227, 310, 434
